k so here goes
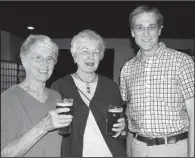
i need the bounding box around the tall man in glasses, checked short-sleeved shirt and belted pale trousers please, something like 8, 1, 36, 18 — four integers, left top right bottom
120, 5, 194, 157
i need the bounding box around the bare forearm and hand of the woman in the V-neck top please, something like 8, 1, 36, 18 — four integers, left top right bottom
1, 108, 72, 157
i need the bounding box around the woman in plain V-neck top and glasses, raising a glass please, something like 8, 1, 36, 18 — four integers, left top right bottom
1, 35, 72, 157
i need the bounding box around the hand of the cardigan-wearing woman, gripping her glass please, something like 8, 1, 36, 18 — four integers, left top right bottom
112, 118, 125, 138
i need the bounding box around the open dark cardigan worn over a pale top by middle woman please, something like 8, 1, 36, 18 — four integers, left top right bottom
51, 75, 126, 157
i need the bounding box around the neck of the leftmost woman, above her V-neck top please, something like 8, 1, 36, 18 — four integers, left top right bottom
21, 77, 45, 94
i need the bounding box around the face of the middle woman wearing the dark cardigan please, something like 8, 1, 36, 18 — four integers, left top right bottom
74, 38, 101, 73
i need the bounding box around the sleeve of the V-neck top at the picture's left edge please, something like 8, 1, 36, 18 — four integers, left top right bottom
1, 91, 21, 148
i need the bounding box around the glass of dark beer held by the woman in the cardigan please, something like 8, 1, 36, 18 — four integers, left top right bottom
106, 105, 123, 136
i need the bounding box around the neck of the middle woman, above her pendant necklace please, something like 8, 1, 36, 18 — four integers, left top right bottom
76, 70, 97, 83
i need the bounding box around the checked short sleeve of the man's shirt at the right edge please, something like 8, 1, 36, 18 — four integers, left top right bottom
179, 56, 194, 100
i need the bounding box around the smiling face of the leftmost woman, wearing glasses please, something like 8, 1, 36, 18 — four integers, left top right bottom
23, 47, 56, 82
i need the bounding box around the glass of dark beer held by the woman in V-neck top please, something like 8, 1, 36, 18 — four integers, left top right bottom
56, 99, 73, 136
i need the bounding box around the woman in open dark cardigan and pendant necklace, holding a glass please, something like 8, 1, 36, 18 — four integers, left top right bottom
52, 30, 126, 157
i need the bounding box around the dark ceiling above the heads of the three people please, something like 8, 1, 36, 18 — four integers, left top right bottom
0, 1, 195, 39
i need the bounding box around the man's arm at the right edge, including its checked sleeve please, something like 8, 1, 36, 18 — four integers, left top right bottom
178, 55, 194, 156
